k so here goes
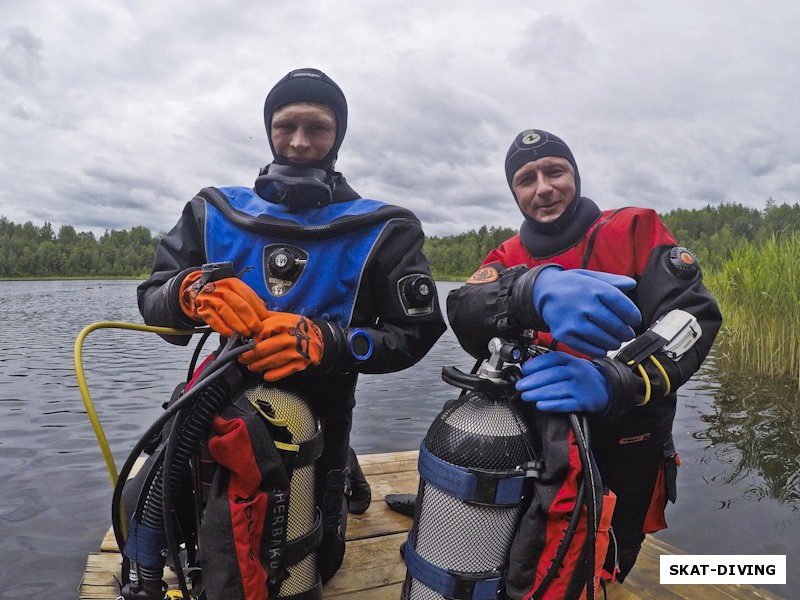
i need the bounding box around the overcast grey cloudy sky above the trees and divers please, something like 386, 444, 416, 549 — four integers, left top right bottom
0, 0, 800, 235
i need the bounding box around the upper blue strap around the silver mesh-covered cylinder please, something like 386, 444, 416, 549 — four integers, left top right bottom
417, 442, 526, 506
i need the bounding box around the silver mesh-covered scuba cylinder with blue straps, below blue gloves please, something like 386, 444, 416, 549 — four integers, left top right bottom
402, 339, 537, 600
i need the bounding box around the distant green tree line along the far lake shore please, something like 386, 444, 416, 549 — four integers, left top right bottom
0, 198, 800, 279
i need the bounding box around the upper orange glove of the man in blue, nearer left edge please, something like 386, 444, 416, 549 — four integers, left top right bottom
180, 271, 268, 338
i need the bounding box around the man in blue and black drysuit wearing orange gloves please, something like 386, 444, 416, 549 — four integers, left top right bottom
138, 69, 446, 580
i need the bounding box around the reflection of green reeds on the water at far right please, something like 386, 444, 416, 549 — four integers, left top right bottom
693, 362, 800, 511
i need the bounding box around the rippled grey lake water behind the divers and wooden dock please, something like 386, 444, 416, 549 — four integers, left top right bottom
0, 281, 800, 600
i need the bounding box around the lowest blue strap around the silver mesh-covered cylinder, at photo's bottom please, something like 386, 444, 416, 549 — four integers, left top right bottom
404, 537, 503, 600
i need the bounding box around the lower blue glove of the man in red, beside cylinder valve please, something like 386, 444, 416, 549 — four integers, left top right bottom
516, 352, 611, 413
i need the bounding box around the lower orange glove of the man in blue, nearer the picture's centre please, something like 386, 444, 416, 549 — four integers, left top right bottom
239, 312, 323, 381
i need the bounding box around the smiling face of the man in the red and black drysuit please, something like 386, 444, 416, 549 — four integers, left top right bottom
511, 156, 575, 223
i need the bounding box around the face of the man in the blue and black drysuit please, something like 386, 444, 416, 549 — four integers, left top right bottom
270, 102, 336, 165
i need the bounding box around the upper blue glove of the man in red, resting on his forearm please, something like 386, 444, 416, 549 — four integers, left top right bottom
533, 267, 642, 357
